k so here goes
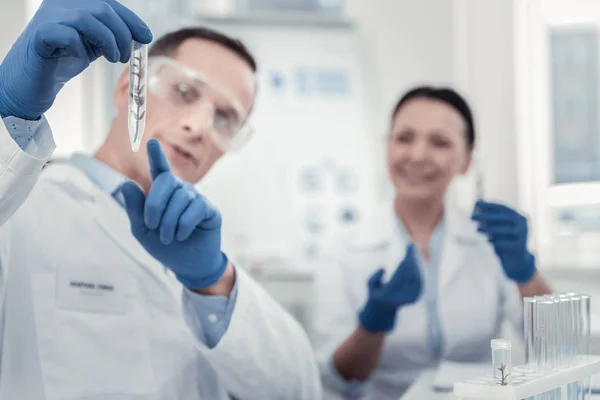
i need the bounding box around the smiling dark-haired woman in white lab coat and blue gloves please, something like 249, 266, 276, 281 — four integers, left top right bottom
316, 87, 551, 400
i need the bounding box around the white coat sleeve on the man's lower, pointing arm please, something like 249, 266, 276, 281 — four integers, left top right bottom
183, 268, 322, 400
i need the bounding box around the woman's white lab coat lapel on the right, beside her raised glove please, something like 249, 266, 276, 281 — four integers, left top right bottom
438, 204, 481, 294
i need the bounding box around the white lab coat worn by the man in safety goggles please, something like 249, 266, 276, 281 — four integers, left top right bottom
0, 122, 321, 400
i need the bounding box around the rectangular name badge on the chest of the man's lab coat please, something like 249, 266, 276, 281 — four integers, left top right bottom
57, 266, 127, 314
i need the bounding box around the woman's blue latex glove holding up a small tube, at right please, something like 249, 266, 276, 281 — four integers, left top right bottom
473, 200, 536, 284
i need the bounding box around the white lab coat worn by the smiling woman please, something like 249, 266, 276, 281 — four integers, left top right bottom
315, 198, 522, 400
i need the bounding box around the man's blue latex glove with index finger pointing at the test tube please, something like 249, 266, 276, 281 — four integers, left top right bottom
122, 139, 228, 290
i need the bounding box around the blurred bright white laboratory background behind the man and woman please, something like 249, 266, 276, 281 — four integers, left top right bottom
0, 0, 600, 362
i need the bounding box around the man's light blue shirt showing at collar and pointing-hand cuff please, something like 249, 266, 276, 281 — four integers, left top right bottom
69, 154, 237, 348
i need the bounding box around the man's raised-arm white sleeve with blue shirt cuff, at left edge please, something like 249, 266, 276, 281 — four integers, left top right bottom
0, 117, 56, 226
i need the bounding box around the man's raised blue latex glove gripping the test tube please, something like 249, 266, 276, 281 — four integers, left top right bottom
0, 0, 152, 120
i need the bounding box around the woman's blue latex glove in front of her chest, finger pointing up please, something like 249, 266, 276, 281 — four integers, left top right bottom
359, 244, 422, 333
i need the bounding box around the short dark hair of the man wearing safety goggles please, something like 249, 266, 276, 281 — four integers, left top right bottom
148, 26, 257, 72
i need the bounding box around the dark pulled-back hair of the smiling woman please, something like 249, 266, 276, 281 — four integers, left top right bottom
392, 86, 475, 150
